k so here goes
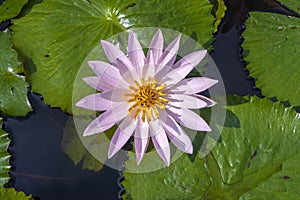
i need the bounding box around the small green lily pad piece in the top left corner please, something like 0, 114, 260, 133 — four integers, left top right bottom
0, 0, 28, 22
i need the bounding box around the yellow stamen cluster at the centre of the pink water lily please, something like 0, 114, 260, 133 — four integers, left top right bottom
125, 76, 169, 122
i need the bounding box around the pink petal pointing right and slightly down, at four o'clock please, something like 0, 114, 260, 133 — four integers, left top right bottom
167, 108, 211, 131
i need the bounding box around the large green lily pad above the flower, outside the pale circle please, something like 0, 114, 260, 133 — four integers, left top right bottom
12, 0, 214, 113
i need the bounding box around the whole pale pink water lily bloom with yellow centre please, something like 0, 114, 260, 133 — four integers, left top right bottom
76, 30, 217, 166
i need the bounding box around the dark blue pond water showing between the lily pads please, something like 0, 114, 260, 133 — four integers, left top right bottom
4, 0, 298, 200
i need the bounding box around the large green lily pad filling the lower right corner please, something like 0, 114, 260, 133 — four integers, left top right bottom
122, 97, 300, 200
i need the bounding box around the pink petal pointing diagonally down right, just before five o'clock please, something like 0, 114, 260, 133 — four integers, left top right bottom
161, 112, 193, 154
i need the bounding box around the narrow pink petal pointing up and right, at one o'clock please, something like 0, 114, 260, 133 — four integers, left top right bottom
157, 34, 181, 71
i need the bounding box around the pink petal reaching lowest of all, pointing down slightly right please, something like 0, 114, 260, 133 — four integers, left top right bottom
149, 120, 170, 166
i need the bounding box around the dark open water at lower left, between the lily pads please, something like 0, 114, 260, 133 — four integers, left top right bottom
5, 93, 121, 200
